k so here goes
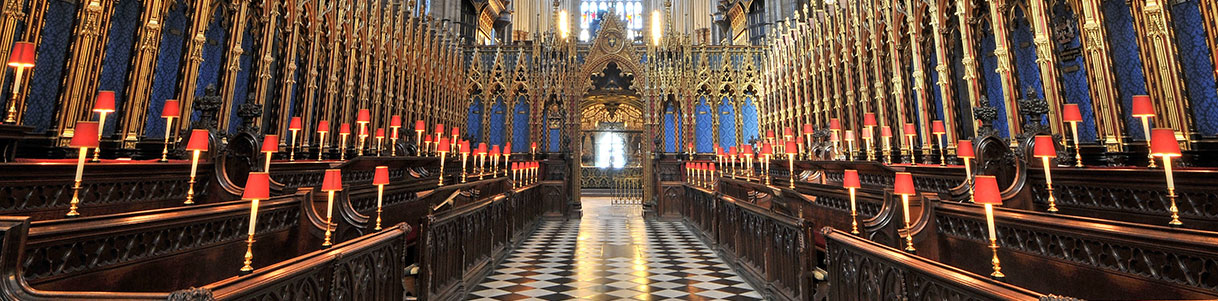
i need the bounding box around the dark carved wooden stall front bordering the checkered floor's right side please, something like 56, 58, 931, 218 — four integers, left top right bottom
685, 185, 816, 300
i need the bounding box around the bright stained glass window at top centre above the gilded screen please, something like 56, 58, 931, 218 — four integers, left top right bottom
579, 0, 644, 43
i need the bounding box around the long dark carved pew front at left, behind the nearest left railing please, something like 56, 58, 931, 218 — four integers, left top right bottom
21, 191, 320, 291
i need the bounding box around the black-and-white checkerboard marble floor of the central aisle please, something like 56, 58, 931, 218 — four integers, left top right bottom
468, 197, 761, 300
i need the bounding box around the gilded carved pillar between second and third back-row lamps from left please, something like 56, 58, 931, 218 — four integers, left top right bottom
116, 0, 169, 149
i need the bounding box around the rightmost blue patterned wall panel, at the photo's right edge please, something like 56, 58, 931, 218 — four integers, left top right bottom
1172, 0, 1218, 135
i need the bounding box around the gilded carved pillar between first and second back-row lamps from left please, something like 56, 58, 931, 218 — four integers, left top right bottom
55, 0, 114, 146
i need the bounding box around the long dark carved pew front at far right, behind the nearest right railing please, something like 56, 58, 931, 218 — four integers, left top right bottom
915, 199, 1218, 300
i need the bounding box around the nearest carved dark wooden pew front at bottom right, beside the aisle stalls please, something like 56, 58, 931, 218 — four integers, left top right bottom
822, 228, 1052, 301
